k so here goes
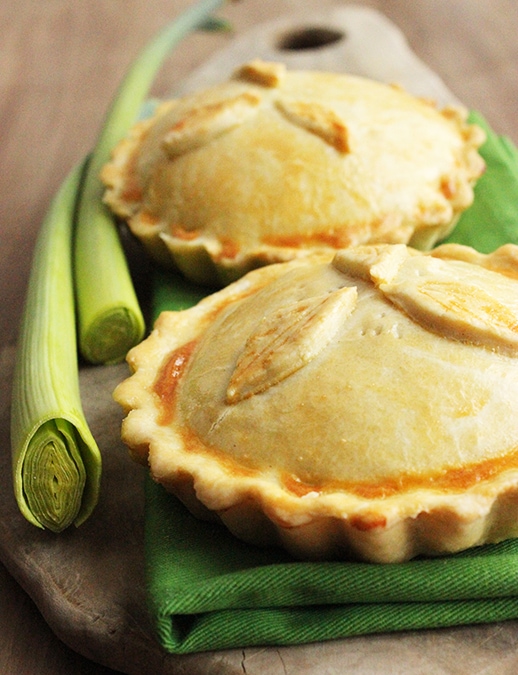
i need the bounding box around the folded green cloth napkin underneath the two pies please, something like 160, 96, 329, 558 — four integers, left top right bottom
145, 113, 518, 653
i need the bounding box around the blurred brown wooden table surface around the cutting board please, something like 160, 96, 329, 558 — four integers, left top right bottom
0, 0, 518, 675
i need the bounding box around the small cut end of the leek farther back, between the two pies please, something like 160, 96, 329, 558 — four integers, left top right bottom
81, 307, 144, 365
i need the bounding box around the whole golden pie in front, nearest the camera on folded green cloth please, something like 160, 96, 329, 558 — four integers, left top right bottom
115, 244, 518, 562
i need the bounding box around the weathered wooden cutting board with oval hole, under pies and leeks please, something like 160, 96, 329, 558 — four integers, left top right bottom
0, 6, 518, 675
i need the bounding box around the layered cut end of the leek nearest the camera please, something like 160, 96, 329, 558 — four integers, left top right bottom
21, 420, 86, 532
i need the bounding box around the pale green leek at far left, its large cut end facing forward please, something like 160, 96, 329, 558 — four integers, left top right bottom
11, 165, 101, 532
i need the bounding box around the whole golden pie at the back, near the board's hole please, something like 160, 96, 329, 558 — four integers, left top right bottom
102, 61, 484, 284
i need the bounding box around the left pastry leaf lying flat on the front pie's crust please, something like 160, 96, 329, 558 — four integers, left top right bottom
227, 287, 357, 404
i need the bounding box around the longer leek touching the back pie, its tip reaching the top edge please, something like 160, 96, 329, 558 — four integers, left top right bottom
75, 0, 232, 363
